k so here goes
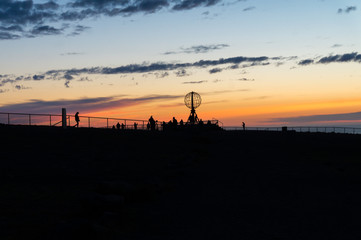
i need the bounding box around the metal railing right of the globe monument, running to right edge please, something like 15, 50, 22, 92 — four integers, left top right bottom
223, 126, 361, 134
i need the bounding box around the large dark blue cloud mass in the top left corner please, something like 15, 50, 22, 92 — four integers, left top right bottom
0, 0, 228, 40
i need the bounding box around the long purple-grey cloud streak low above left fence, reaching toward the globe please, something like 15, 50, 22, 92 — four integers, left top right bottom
0, 95, 184, 114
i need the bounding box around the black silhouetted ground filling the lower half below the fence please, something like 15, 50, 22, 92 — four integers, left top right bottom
0, 125, 361, 240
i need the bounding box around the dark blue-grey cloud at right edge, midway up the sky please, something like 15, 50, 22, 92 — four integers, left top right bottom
298, 52, 361, 65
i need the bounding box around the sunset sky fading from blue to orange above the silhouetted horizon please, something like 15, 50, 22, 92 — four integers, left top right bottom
0, 0, 361, 127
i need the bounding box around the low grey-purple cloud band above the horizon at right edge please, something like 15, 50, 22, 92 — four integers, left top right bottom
270, 112, 361, 123
